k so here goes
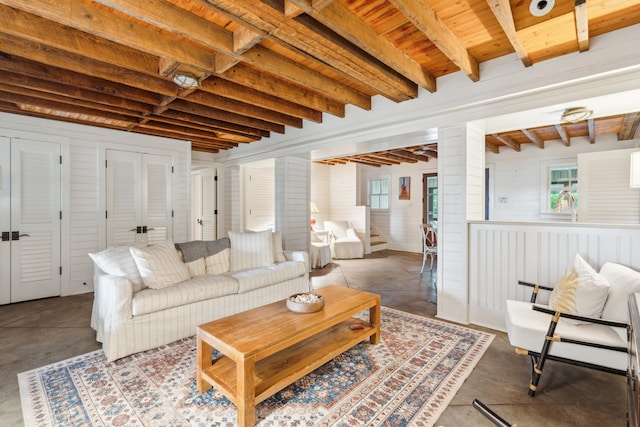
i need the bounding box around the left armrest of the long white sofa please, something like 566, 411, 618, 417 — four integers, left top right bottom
91, 268, 133, 341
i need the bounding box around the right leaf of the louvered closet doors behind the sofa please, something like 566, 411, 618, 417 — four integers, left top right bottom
142, 154, 173, 245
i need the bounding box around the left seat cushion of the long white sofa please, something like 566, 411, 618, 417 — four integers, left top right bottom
132, 275, 238, 318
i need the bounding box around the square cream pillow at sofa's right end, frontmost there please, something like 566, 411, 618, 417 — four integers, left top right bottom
229, 230, 273, 271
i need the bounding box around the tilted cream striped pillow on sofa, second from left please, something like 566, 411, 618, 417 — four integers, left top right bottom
131, 242, 190, 289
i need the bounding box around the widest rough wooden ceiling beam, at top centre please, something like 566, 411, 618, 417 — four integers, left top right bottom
202, 0, 417, 102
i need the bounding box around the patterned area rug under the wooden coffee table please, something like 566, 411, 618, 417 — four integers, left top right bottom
18, 307, 494, 427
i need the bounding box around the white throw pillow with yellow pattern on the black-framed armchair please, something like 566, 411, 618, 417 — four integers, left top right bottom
549, 254, 609, 317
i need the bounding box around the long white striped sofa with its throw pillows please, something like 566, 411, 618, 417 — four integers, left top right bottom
90, 231, 310, 361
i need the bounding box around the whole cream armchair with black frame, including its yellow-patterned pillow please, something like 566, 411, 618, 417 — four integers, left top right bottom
505, 255, 640, 397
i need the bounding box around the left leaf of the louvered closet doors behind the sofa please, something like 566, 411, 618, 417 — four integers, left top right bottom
106, 150, 143, 246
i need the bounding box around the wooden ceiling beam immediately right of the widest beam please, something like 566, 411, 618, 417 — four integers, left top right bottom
287, 0, 436, 92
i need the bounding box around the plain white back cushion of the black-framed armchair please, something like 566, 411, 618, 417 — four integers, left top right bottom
600, 262, 640, 323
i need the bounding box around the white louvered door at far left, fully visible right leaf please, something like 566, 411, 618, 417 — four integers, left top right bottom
10, 138, 61, 302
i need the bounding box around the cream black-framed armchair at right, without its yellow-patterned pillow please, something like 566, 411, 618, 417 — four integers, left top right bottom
506, 262, 640, 396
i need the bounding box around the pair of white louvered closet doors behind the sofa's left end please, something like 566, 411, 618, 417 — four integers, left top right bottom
106, 150, 173, 246
